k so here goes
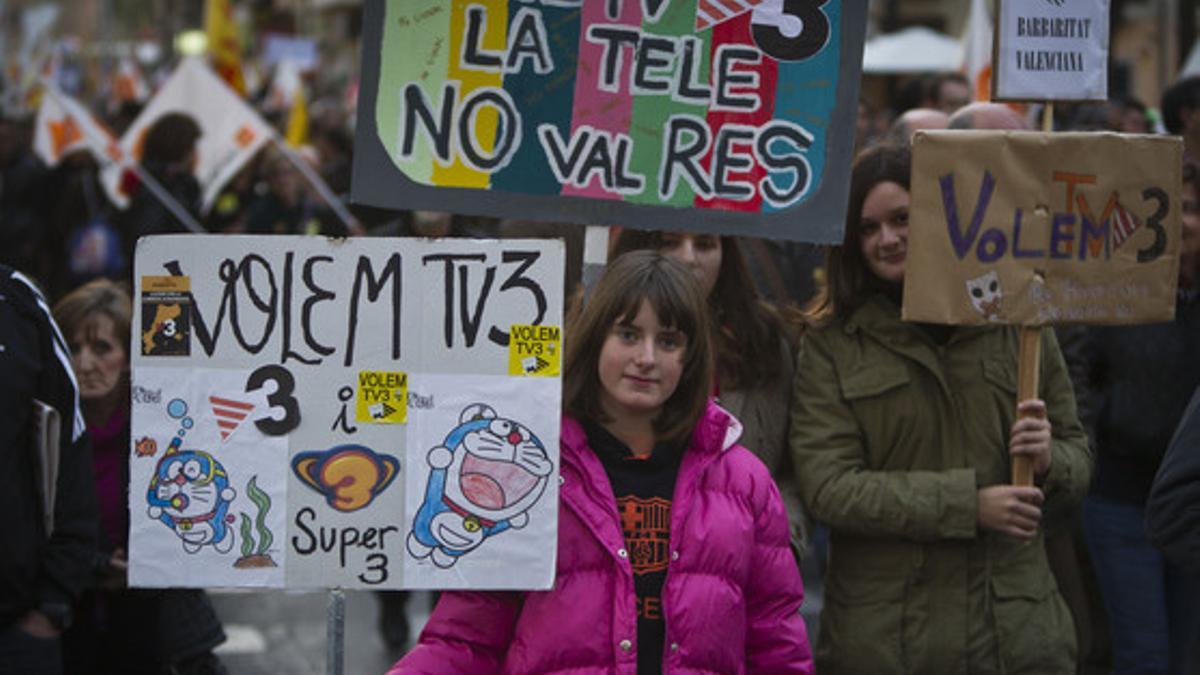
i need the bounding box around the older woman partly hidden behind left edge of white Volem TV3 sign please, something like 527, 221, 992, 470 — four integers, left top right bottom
54, 279, 226, 675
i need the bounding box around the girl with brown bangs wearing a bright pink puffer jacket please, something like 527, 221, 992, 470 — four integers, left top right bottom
390, 251, 812, 675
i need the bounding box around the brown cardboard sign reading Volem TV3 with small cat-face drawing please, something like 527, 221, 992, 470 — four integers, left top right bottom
904, 131, 1183, 325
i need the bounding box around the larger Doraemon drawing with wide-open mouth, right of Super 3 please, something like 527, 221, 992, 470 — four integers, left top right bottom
407, 404, 554, 568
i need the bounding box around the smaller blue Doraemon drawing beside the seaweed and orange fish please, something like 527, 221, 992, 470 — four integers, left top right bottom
146, 436, 236, 554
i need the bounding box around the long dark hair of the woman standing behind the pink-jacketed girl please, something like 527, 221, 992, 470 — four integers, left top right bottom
608, 229, 792, 389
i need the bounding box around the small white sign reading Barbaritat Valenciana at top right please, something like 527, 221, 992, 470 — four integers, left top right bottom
992, 0, 1110, 101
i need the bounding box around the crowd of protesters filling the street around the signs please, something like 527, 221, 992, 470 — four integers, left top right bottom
0, 59, 1200, 674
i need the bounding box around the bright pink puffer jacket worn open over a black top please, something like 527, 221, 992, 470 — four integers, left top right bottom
389, 404, 812, 675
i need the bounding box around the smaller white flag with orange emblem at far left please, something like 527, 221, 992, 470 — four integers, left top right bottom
34, 82, 130, 208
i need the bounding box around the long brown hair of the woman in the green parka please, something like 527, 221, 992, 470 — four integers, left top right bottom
805, 144, 912, 324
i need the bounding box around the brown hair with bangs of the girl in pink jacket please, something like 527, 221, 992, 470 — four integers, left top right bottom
563, 251, 713, 442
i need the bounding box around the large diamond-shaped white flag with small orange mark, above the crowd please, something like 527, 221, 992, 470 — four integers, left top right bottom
121, 56, 276, 211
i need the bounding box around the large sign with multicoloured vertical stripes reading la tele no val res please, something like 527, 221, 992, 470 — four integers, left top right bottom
353, 0, 865, 241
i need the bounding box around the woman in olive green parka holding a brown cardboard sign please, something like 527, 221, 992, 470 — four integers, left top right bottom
790, 147, 1091, 675
